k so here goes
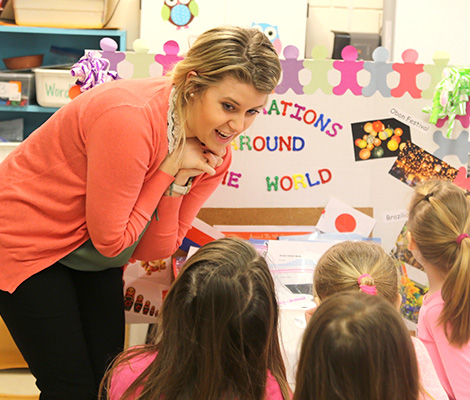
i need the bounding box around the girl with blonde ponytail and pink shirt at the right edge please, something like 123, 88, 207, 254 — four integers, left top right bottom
407, 181, 470, 400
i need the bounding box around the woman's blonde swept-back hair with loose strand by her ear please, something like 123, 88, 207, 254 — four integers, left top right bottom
170, 26, 282, 152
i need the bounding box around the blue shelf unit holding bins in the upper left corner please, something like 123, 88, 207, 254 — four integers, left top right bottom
0, 25, 126, 139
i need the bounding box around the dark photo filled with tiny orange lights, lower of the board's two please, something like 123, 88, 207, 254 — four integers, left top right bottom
388, 142, 458, 187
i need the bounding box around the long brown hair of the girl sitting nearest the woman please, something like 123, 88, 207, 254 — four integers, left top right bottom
101, 238, 289, 400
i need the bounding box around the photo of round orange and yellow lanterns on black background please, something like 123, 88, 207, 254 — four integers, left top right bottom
351, 118, 411, 161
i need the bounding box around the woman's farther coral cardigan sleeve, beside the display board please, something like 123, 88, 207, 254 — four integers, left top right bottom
133, 148, 232, 261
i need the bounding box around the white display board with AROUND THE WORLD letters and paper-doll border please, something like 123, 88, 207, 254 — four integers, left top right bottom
96, 38, 470, 250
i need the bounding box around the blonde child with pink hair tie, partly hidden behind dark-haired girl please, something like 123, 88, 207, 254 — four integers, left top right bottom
313, 241, 448, 400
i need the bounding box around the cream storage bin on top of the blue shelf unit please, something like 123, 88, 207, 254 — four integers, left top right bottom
13, 0, 107, 29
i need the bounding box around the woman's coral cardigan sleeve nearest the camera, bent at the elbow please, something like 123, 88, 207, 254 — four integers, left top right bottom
85, 106, 174, 257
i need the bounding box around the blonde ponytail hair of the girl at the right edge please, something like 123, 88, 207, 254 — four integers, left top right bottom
407, 180, 470, 347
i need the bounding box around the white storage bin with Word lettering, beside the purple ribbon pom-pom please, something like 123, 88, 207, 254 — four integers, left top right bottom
33, 68, 77, 107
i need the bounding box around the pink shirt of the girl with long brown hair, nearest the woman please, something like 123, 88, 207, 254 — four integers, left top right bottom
109, 353, 284, 400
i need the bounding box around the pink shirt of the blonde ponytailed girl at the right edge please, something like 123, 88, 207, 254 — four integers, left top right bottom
418, 290, 470, 400
